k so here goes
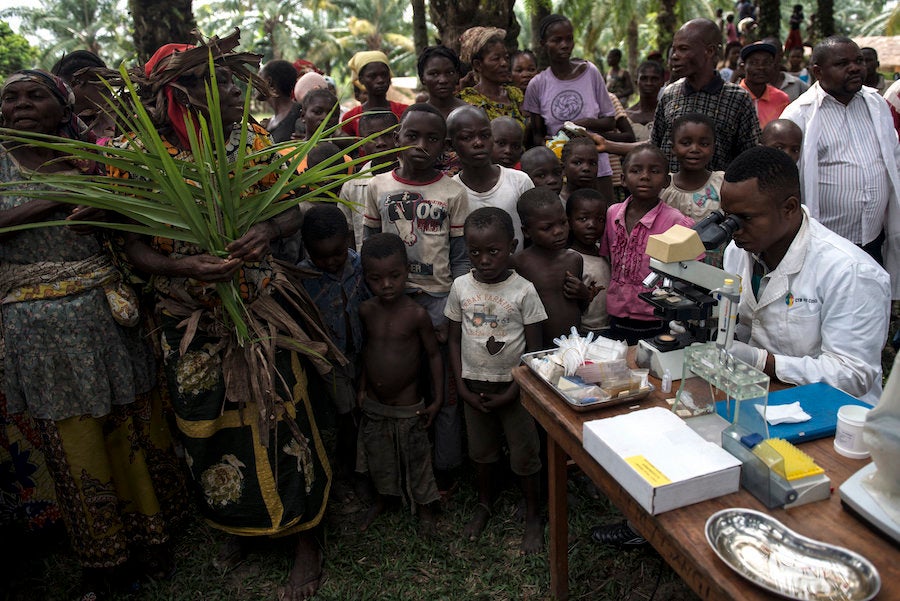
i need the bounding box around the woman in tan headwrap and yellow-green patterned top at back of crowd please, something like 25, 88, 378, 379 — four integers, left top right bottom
459, 27, 525, 127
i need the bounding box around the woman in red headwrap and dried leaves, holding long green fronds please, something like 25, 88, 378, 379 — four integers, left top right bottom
110, 32, 344, 601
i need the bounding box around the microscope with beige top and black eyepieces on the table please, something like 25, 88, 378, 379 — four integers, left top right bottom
637, 211, 741, 378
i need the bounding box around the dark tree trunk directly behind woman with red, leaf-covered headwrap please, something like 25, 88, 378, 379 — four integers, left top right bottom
128, 0, 194, 62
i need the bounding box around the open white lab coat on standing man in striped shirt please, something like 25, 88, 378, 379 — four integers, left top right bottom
781, 82, 900, 299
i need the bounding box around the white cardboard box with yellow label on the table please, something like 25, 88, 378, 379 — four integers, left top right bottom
584, 407, 741, 515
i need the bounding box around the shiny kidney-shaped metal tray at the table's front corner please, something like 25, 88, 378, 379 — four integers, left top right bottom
706, 508, 881, 601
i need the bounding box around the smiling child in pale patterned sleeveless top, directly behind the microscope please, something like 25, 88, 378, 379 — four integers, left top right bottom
660, 113, 725, 221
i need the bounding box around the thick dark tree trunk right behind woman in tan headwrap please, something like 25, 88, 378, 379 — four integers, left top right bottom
428, 0, 521, 52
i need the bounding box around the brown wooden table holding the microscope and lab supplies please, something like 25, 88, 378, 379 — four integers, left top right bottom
513, 366, 900, 601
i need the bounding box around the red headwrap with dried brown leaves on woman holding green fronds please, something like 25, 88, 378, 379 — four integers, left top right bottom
131, 28, 271, 148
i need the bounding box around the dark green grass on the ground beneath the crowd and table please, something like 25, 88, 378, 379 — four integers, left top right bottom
2, 473, 696, 601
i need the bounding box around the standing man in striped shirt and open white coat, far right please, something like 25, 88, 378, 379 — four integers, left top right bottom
782, 36, 900, 298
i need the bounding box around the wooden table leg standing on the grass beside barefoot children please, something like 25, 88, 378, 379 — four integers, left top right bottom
547, 436, 569, 601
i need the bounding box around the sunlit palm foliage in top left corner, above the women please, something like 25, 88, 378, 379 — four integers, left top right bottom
0, 0, 134, 68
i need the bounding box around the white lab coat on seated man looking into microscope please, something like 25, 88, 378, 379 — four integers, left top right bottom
724, 207, 891, 405
